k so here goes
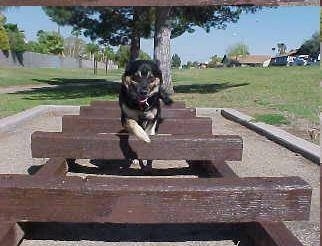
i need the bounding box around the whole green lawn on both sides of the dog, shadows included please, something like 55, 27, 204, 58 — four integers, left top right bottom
0, 66, 321, 126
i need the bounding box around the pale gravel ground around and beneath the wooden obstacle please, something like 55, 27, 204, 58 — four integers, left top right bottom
0, 108, 320, 246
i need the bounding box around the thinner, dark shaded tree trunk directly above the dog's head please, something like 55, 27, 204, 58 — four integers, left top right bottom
130, 7, 142, 61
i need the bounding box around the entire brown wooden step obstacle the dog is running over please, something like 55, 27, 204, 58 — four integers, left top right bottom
0, 102, 311, 246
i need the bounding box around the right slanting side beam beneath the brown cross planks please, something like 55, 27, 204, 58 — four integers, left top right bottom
196, 161, 303, 246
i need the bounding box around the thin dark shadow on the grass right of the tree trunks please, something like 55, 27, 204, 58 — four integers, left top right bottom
174, 82, 249, 94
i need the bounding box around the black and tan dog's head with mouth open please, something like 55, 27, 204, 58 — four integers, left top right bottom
122, 60, 162, 102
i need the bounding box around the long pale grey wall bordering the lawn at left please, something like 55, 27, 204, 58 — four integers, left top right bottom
0, 52, 118, 70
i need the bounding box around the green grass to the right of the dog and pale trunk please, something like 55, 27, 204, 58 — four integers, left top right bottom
173, 66, 322, 122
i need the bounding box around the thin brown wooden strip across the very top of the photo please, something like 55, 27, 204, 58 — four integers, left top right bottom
0, 0, 318, 6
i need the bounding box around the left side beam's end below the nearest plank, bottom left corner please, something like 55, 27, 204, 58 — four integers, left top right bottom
0, 223, 24, 246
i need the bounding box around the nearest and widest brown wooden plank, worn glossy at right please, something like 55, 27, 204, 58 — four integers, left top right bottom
0, 175, 311, 224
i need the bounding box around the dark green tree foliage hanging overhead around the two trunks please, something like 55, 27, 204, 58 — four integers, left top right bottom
43, 6, 261, 46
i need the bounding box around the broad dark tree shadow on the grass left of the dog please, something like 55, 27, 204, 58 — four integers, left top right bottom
11, 78, 120, 100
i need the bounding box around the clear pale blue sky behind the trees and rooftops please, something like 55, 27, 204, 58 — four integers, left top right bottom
5, 6, 320, 63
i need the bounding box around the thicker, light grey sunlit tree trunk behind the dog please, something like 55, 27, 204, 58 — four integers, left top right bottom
153, 7, 173, 94
